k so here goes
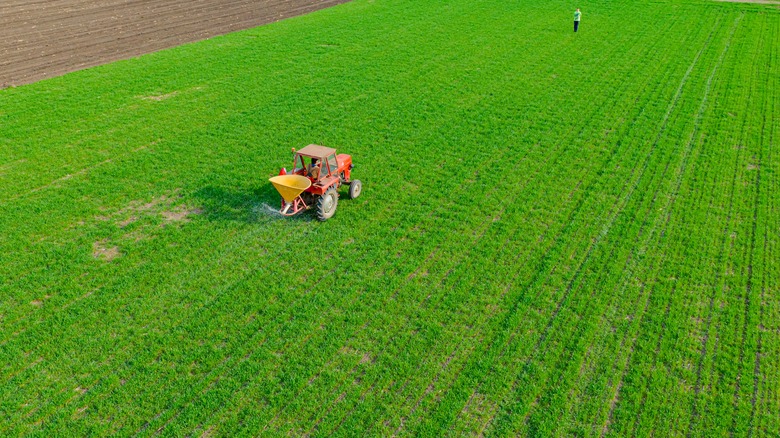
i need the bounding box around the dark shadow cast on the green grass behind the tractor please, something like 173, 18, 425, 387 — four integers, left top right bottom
194, 185, 306, 223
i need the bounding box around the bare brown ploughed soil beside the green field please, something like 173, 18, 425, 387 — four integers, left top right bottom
0, 0, 349, 88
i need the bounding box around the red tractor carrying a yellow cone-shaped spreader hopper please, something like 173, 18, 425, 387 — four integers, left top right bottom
270, 144, 363, 221
